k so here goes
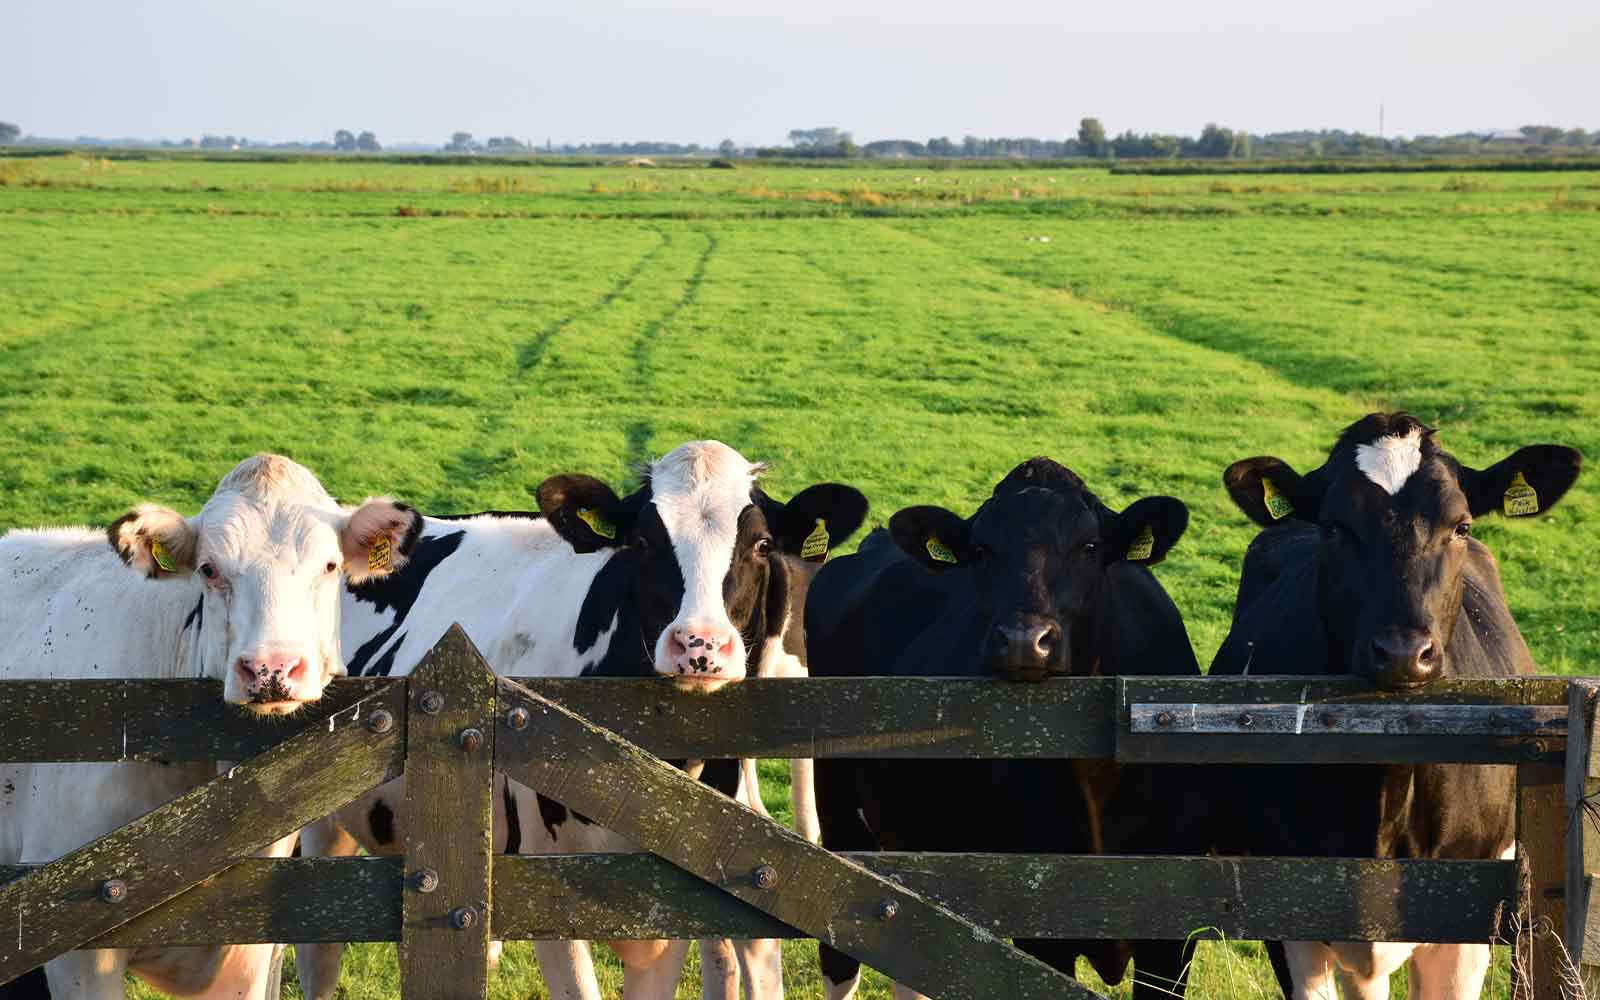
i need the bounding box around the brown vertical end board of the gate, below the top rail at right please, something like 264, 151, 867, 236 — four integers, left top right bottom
1512, 763, 1566, 1000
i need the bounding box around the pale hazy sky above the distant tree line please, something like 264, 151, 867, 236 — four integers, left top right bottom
12, 0, 1600, 146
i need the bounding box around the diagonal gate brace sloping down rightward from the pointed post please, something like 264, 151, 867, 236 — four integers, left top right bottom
496, 680, 1094, 1000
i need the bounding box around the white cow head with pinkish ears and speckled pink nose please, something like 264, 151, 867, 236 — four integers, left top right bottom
107, 454, 422, 714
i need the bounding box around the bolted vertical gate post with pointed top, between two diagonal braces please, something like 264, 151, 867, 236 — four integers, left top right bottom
400, 626, 494, 1000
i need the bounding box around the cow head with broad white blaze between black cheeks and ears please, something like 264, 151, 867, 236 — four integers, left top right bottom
538, 442, 867, 690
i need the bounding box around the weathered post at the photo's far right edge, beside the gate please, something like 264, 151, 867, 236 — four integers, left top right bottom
1565, 680, 1600, 1000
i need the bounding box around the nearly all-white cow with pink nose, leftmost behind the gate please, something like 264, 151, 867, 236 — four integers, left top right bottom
0, 454, 421, 1000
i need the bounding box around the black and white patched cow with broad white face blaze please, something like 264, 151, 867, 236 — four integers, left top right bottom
301, 442, 867, 998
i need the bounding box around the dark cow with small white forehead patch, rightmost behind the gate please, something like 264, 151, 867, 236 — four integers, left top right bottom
1211, 413, 1582, 1000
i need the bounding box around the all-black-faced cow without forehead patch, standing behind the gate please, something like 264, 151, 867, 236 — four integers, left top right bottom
806, 458, 1206, 1000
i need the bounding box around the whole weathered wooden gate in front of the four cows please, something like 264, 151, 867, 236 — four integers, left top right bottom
0, 629, 1600, 1000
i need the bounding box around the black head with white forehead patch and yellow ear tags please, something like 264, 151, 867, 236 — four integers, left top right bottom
1222, 413, 1582, 690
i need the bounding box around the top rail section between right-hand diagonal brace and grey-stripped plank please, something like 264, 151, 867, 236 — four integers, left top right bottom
499, 677, 1114, 758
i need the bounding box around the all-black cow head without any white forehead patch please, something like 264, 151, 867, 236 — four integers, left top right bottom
890, 458, 1189, 682
